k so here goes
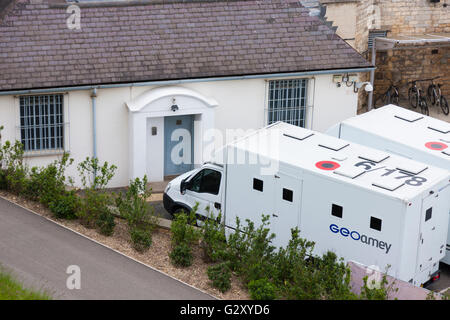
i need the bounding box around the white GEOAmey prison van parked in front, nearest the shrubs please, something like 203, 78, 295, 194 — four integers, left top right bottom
164, 122, 450, 285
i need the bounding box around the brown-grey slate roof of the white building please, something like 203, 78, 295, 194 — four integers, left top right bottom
0, 0, 371, 91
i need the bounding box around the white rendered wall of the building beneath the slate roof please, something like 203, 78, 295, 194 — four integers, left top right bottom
0, 75, 357, 187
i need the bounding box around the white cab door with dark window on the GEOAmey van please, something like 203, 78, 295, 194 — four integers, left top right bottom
185, 168, 222, 216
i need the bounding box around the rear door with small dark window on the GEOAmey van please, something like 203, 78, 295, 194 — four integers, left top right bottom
418, 195, 440, 272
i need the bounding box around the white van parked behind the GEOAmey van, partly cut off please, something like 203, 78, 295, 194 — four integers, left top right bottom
327, 105, 450, 265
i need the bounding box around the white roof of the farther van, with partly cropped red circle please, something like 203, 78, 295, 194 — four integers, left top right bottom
341, 104, 450, 168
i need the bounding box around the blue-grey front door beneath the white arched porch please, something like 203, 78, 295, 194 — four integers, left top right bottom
164, 115, 194, 176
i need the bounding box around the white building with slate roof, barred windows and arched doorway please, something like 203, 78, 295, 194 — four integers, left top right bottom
0, 0, 372, 187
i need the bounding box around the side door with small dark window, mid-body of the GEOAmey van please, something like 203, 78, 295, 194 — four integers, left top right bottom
271, 172, 303, 247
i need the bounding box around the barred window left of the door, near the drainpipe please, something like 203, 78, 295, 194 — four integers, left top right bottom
20, 94, 64, 151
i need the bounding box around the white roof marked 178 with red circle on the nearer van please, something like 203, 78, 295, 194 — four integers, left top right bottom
222, 122, 450, 201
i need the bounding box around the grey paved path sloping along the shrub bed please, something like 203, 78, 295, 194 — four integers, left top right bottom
0, 198, 212, 300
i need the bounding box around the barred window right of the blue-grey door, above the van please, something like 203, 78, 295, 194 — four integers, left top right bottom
268, 79, 308, 127
